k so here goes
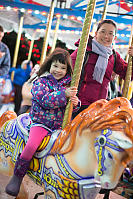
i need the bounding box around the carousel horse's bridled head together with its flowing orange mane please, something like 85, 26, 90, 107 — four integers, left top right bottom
53, 97, 133, 189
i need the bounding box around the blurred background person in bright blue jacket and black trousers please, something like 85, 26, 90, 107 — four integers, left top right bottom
9, 60, 33, 114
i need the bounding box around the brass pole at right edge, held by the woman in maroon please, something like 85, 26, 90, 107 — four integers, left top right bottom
122, 26, 133, 97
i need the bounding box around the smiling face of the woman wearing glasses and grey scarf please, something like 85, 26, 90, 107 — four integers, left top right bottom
95, 23, 116, 47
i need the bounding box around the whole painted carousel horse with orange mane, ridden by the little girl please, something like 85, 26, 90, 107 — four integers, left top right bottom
0, 97, 133, 199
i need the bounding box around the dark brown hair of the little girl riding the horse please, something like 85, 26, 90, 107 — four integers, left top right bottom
37, 48, 73, 76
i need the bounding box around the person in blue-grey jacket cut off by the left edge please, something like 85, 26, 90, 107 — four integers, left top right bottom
0, 25, 11, 76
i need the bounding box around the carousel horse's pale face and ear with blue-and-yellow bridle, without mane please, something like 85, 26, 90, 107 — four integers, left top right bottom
95, 129, 133, 189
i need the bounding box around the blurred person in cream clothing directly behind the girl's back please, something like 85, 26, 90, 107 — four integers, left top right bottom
17, 64, 40, 115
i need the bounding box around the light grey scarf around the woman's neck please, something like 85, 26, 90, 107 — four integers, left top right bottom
92, 39, 113, 84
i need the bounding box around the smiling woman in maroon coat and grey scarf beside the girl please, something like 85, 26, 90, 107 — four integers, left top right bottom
71, 19, 133, 118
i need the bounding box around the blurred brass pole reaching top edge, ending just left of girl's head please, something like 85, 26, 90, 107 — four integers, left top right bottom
40, 0, 54, 65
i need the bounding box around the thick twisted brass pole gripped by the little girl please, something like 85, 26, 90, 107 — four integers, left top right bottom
62, 0, 96, 128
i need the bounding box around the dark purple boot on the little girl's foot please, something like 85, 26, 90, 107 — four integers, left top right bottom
5, 155, 30, 196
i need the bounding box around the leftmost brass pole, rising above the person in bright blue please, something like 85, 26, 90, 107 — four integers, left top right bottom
11, 12, 24, 81
